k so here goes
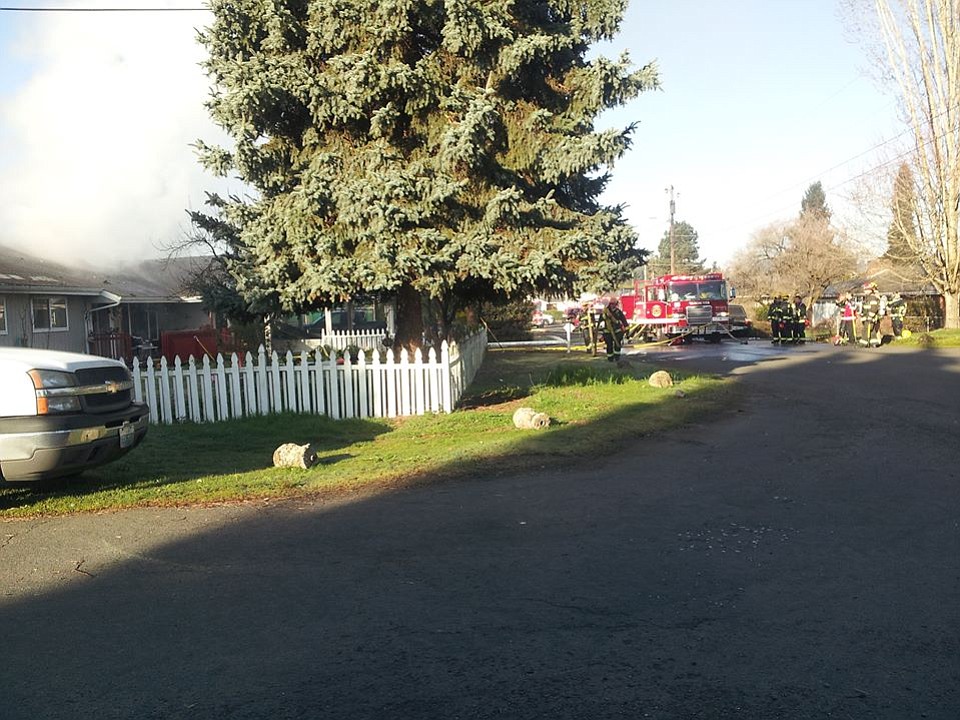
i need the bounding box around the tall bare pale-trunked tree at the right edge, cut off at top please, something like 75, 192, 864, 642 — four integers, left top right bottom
873, 0, 960, 328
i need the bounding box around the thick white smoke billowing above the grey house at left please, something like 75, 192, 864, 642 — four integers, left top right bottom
0, 2, 223, 266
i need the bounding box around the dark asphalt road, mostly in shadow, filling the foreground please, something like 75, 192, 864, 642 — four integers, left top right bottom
0, 342, 960, 720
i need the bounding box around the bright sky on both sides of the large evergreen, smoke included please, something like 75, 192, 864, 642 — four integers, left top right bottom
0, 0, 903, 266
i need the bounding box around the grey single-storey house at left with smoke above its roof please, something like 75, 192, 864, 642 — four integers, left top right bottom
0, 247, 214, 362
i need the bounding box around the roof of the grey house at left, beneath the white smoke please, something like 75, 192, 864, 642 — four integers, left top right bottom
0, 246, 213, 303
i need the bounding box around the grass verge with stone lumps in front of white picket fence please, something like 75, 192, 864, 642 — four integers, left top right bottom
0, 350, 737, 518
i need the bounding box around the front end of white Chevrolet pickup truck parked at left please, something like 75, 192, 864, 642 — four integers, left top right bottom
0, 348, 150, 482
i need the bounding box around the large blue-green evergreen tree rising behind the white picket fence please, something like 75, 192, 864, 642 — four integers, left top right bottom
195, 0, 658, 344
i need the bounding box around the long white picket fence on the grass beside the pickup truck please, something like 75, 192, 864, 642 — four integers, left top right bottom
133, 331, 487, 424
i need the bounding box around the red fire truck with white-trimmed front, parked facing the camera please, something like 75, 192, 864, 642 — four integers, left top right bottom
620, 273, 730, 342
